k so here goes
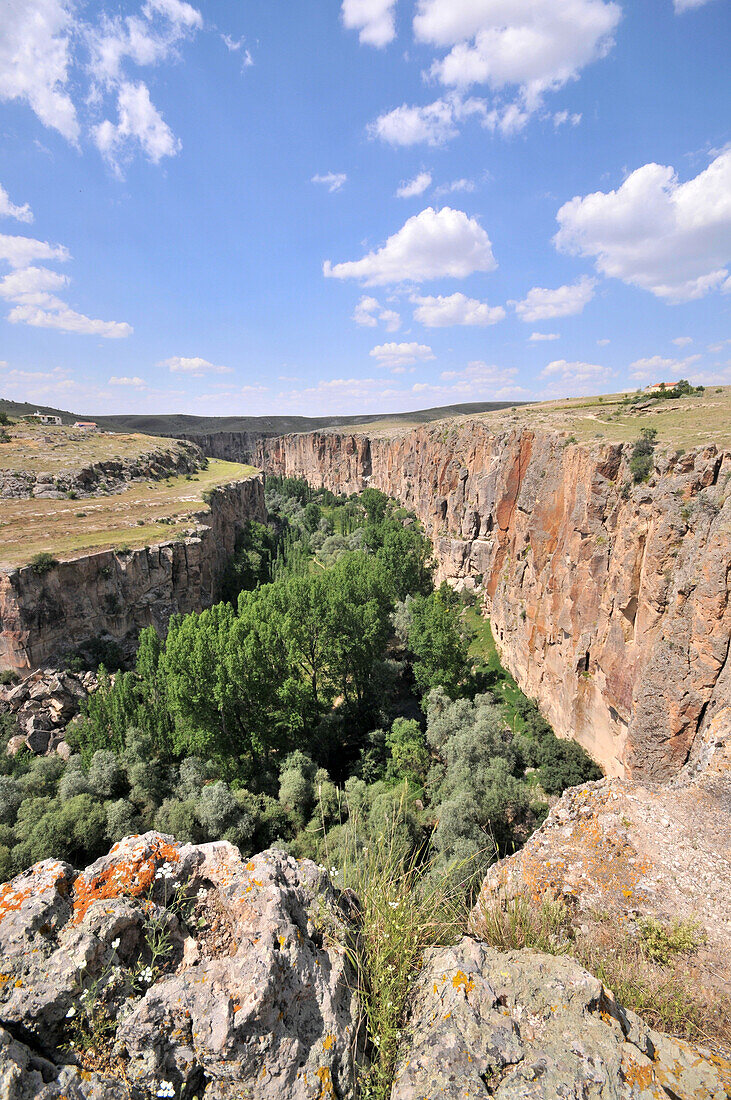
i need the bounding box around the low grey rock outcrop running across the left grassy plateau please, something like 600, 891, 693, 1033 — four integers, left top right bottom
0, 440, 203, 499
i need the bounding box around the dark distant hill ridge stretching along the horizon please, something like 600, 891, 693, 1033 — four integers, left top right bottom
0, 399, 525, 436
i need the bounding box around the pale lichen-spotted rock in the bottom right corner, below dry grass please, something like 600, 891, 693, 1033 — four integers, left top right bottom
391, 937, 731, 1100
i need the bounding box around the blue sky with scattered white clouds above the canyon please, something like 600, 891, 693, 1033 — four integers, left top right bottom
0, 0, 731, 416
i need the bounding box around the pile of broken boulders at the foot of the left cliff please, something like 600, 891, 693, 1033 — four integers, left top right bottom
0, 669, 97, 756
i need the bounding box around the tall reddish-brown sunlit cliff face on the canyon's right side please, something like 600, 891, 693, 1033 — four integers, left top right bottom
256, 421, 731, 780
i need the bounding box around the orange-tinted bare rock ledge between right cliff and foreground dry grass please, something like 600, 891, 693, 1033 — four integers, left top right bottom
476, 770, 731, 1000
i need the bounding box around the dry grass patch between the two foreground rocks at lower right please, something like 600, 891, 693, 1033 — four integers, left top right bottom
470, 894, 731, 1057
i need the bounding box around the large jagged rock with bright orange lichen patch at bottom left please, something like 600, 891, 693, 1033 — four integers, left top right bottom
0, 833, 357, 1100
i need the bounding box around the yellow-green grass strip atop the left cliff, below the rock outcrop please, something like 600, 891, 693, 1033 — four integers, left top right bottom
0, 460, 257, 567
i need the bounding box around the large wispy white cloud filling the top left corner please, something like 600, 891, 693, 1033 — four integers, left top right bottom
0, 0, 80, 143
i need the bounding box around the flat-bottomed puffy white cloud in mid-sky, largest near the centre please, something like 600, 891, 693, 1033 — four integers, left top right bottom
323, 207, 497, 286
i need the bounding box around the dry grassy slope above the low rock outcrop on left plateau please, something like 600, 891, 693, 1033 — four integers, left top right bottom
0, 420, 193, 475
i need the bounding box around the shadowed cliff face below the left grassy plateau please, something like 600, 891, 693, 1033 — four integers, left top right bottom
0, 477, 266, 671
